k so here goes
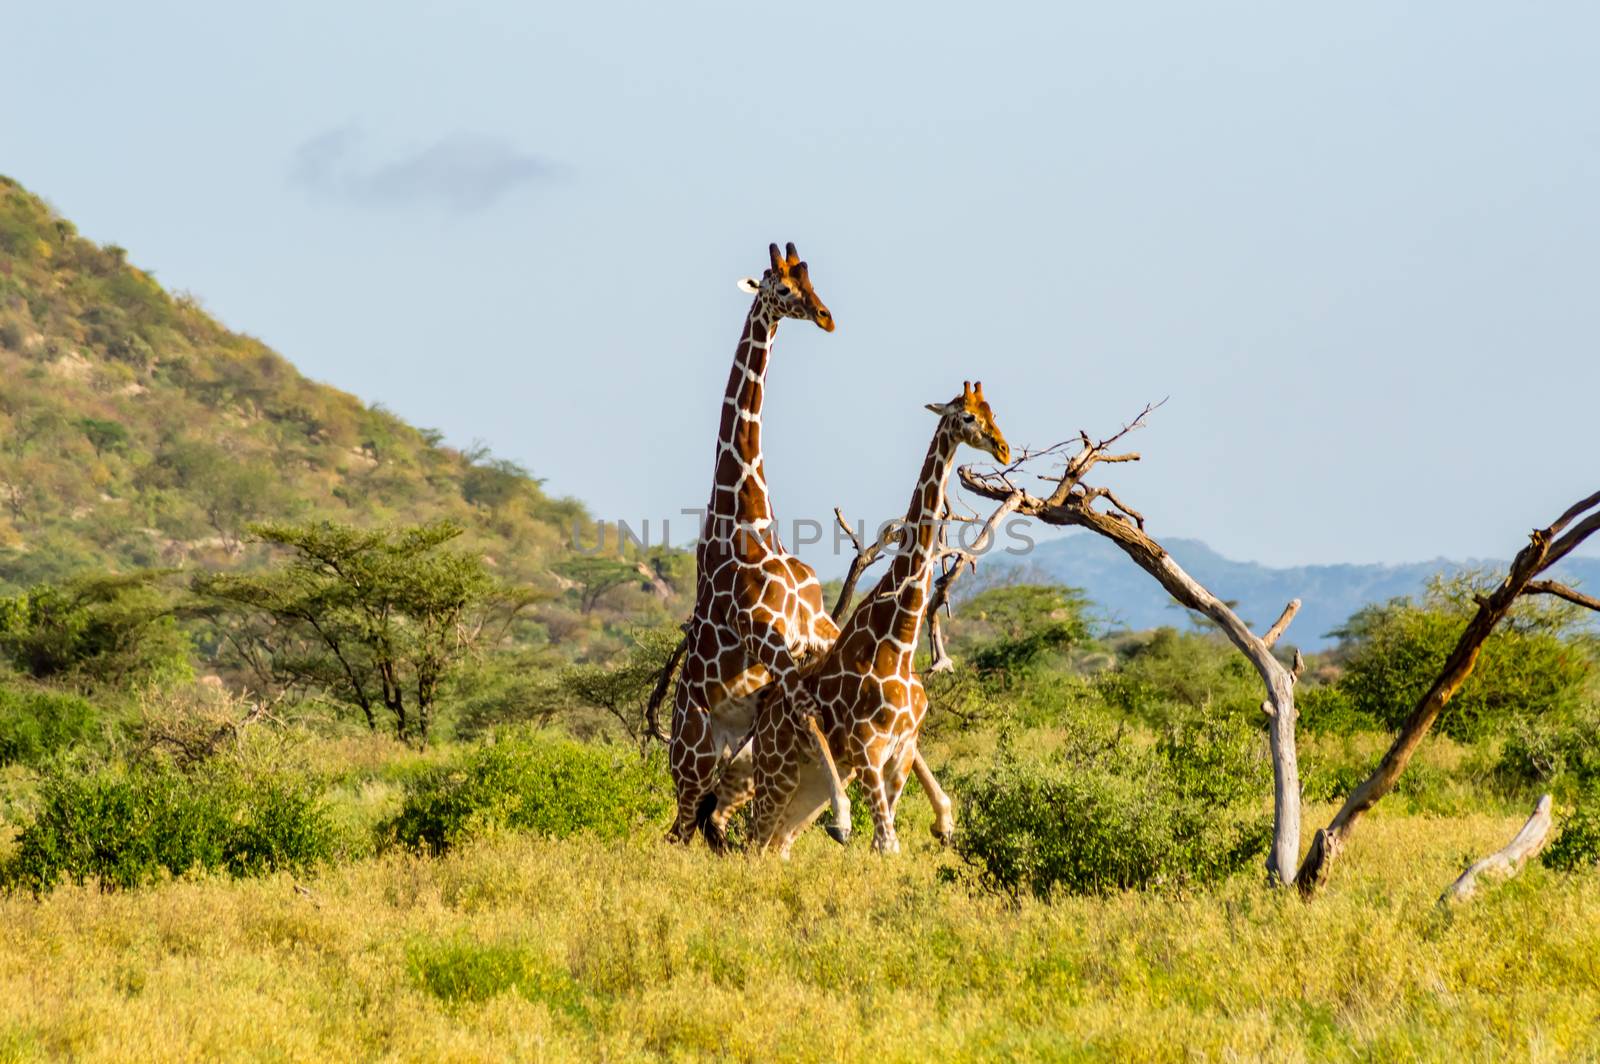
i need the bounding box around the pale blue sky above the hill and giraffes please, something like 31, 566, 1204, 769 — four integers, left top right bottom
0, 0, 1600, 568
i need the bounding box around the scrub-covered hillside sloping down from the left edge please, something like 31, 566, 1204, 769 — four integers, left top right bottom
0, 178, 675, 642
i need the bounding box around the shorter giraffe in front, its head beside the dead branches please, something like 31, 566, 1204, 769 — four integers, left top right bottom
732, 382, 1011, 858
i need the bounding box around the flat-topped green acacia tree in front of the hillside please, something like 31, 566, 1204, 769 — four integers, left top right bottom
194, 522, 526, 741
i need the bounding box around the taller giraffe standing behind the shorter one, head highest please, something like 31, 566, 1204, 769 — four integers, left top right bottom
669, 243, 850, 842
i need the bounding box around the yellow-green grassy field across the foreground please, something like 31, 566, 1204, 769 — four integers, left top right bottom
0, 752, 1600, 1061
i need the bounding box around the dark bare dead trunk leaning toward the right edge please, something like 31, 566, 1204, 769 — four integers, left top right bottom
1296, 491, 1600, 898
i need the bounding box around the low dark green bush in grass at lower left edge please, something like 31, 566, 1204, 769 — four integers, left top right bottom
0, 770, 333, 894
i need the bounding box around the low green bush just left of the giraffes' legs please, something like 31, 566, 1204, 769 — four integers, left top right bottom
378, 733, 674, 853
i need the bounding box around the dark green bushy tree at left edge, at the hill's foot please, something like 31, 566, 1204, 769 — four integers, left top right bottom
0, 570, 194, 686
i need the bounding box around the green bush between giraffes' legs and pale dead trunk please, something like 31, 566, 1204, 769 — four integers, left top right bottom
955, 722, 1272, 899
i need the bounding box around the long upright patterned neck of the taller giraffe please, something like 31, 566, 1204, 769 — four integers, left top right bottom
702, 296, 778, 542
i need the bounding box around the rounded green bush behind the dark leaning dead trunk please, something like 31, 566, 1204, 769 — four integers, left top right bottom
1336, 574, 1594, 741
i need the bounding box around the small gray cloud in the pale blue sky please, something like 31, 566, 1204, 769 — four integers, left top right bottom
290, 126, 554, 213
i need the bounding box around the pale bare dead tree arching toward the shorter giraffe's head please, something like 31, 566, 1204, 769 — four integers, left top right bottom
960, 405, 1304, 886
